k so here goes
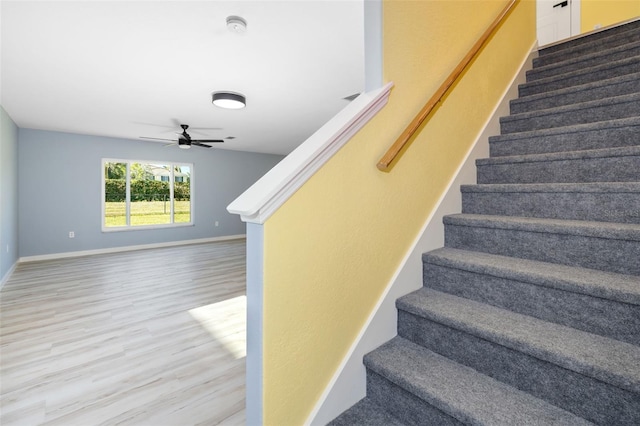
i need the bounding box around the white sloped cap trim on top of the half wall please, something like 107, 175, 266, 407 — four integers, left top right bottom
227, 83, 393, 224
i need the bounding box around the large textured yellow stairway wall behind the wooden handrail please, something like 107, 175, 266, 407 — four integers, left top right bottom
263, 0, 535, 426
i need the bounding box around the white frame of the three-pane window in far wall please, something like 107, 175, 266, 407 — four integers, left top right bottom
100, 158, 195, 232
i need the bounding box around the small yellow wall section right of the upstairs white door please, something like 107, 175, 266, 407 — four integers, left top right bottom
580, 0, 640, 33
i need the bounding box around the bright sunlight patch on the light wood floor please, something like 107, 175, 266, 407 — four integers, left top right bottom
189, 295, 247, 359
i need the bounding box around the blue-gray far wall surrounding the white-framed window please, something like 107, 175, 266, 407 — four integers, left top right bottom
18, 129, 283, 257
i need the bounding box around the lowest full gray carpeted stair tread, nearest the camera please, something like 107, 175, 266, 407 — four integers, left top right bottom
365, 337, 591, 425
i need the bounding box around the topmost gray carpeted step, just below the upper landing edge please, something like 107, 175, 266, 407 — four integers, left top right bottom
539, 19, 640, 59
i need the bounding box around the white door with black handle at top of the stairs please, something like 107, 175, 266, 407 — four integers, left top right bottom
536, 0, 580, 46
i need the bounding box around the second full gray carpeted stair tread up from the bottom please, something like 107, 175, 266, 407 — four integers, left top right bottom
396, 287, 640, 396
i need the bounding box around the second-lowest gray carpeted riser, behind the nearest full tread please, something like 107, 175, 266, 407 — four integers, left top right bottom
398, 310, 640, 425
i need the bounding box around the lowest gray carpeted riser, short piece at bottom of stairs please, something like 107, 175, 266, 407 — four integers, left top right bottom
367, 369, 463, 426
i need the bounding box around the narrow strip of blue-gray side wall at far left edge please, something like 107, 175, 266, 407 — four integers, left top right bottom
0, 106, 18, 285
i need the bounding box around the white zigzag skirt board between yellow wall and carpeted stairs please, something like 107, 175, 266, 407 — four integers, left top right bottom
305, 45, 537, 425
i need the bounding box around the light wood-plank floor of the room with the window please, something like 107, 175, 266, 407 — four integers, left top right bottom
0, 240, 246, 426
